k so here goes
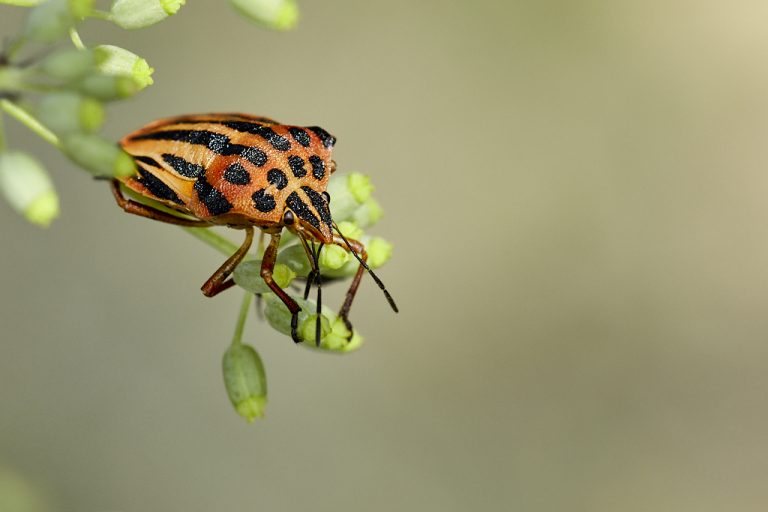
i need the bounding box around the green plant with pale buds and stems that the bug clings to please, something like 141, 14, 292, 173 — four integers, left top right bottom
0, 0, 392, 420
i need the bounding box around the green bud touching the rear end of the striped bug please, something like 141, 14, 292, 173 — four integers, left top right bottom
64, 133, 136, 177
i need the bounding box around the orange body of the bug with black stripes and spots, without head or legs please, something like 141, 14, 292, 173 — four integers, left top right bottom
121, 114, 335, 225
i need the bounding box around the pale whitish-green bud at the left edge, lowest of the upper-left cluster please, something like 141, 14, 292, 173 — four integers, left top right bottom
0, 151, 59, 227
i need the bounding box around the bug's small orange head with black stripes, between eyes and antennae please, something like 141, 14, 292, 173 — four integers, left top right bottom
283, 187, 333, 244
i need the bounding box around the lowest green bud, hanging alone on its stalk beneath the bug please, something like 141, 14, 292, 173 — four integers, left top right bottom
222, 343, 267, 422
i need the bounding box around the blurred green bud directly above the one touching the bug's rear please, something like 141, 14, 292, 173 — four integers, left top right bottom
37, 92, 104, 134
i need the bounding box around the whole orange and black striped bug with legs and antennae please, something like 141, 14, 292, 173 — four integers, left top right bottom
112, 114, 397, 343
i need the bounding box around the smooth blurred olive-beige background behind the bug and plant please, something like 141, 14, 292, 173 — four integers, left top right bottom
0, 0, 768, 512
